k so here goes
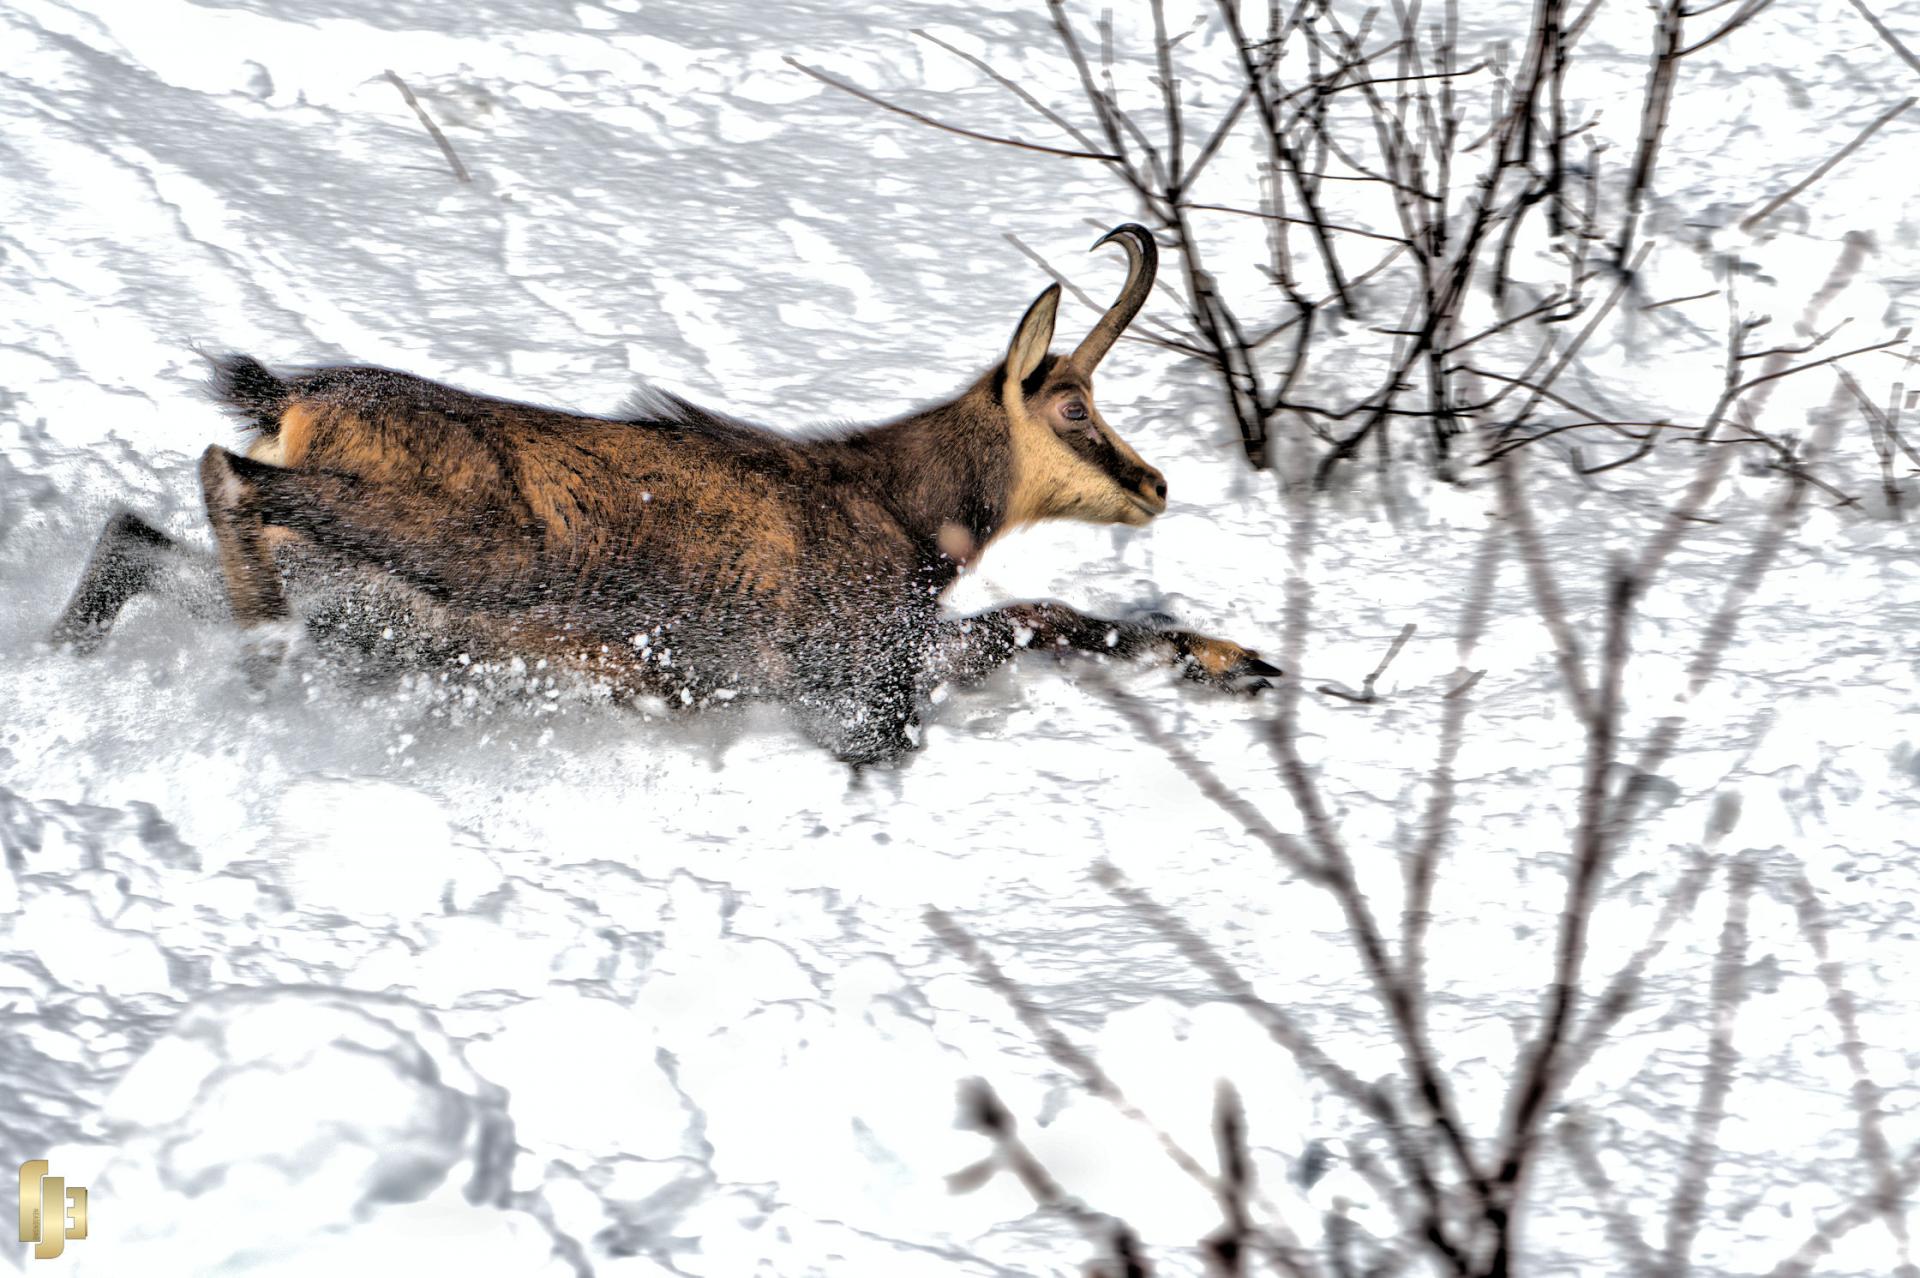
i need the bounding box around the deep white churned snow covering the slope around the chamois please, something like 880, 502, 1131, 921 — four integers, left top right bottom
0, 0, 1920, 1278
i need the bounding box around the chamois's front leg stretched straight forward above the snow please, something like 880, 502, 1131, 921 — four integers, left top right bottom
933, 603, 1281, 691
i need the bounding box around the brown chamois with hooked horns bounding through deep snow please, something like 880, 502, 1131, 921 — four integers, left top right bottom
52, 223, 1279, 762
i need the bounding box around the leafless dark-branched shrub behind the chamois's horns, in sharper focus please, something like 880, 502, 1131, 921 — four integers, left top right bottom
795, 0, 1914, 487
